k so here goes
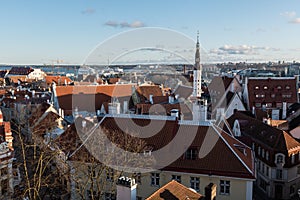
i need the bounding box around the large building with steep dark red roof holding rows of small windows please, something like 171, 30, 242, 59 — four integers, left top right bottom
243, 77, 298, 119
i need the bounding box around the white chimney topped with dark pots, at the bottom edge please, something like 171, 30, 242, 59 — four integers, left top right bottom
117, 176, 137, 200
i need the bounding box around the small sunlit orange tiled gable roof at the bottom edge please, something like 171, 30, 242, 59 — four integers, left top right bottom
146, 180, 204, 200
